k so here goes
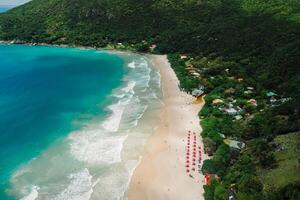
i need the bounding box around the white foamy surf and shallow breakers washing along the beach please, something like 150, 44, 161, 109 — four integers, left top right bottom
9, 52, 160, 200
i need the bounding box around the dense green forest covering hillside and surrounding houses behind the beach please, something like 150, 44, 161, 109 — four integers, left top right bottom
0, 0, 300, 200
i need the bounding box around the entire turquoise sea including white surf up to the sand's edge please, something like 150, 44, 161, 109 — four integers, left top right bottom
0, 45, 162, 200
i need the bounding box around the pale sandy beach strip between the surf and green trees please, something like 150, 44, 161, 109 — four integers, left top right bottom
127, 55, 207, 200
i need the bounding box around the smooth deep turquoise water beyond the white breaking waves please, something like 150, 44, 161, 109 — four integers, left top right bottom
0, 45, 124, 199
